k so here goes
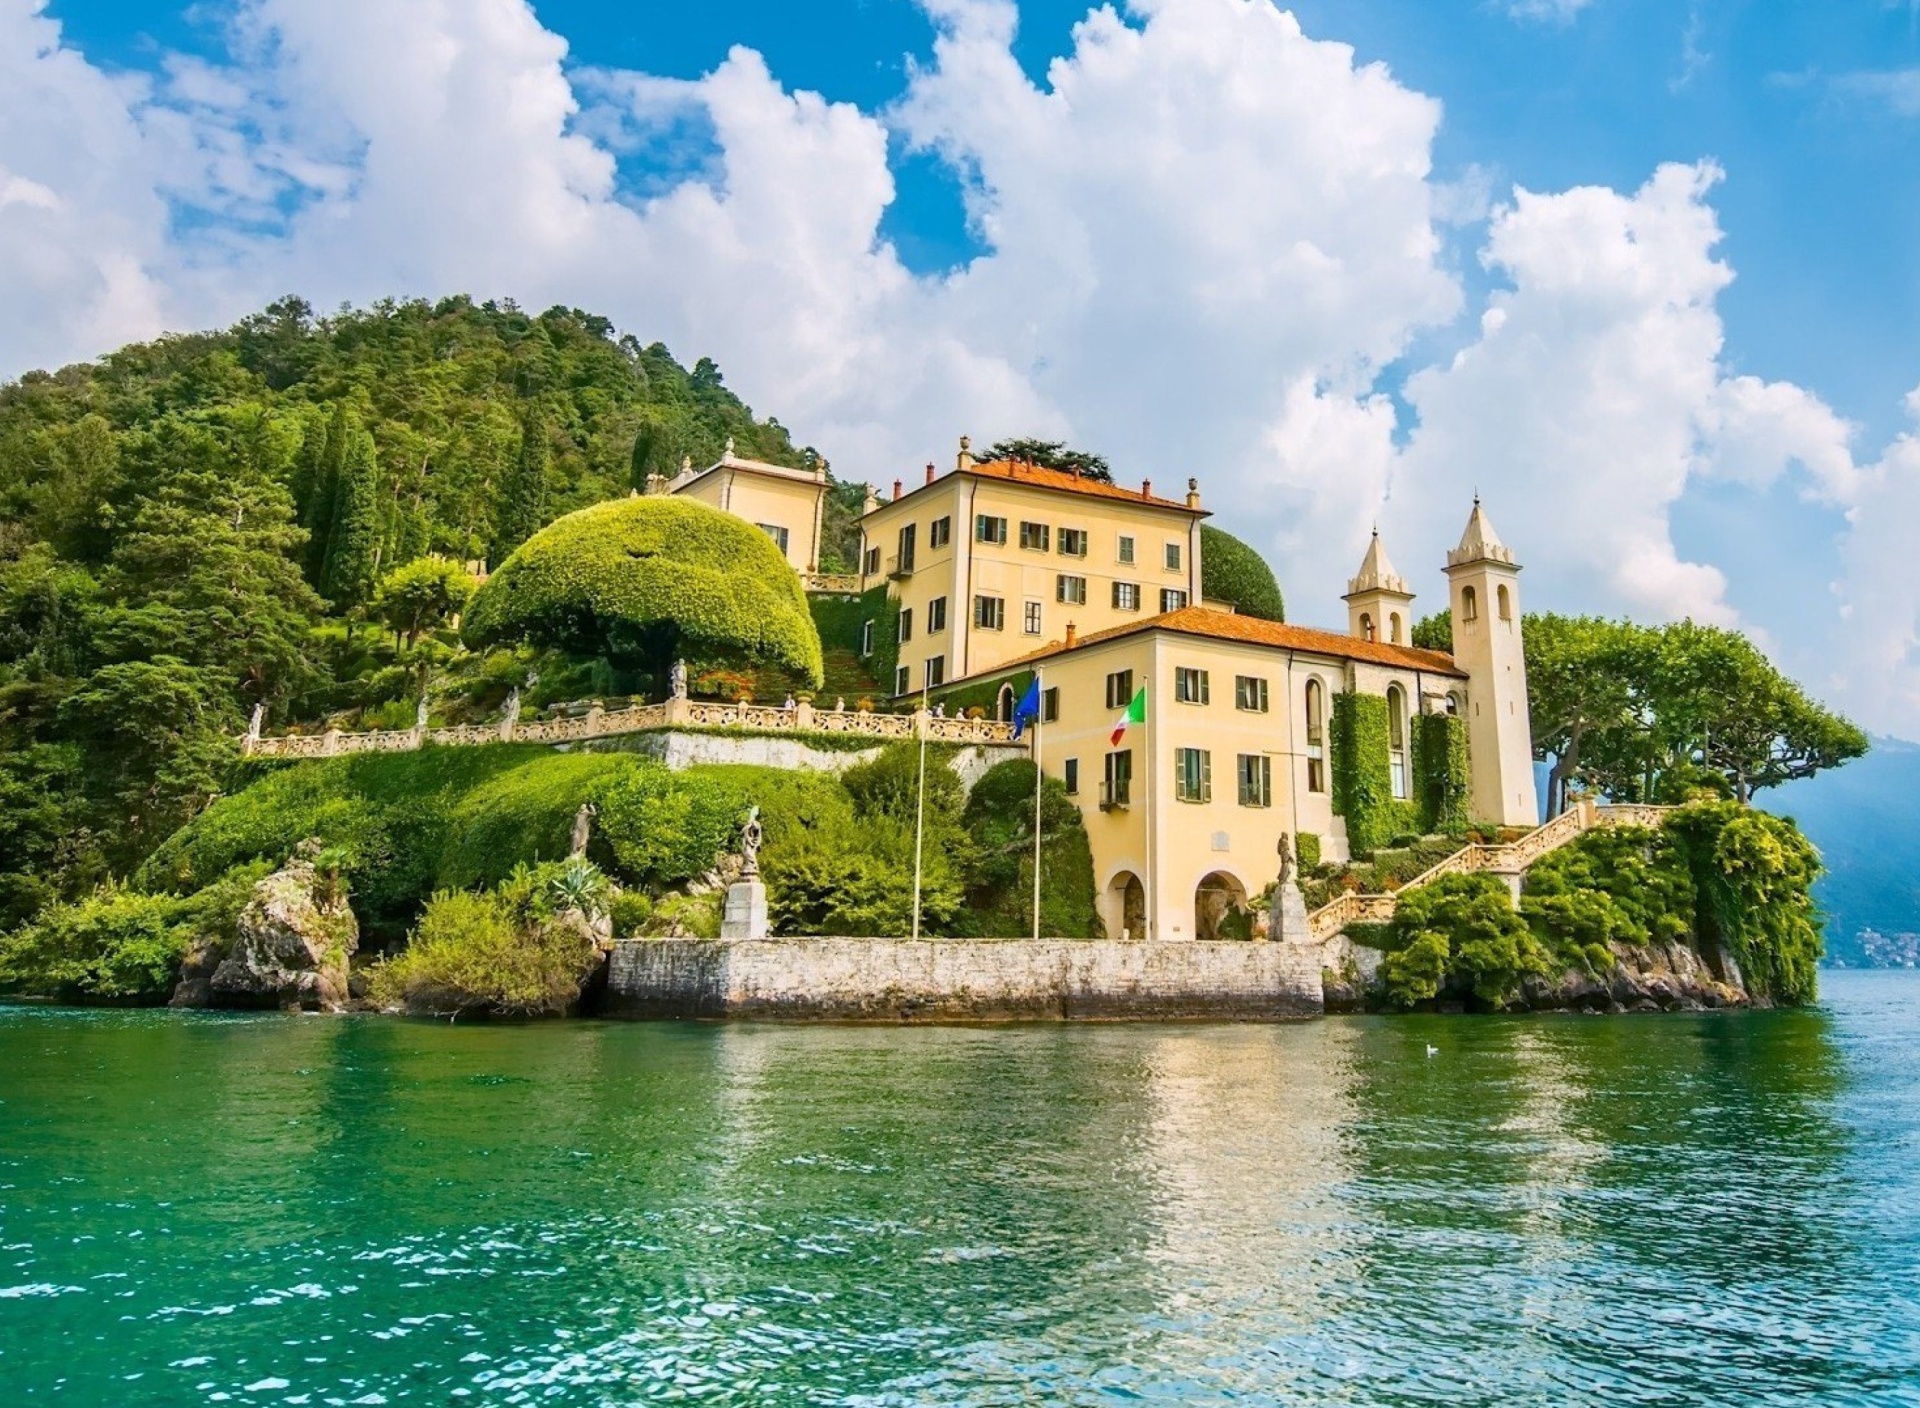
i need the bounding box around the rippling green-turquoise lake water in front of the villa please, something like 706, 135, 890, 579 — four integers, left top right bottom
0, 974, 1920, 1404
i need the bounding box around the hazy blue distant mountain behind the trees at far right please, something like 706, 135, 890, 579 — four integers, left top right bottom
1759, 738, 1920, 968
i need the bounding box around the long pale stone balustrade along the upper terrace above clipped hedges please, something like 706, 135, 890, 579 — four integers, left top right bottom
240, 699, 1014, 759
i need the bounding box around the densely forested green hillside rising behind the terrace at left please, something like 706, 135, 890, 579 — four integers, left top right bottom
0, 298, 814, 928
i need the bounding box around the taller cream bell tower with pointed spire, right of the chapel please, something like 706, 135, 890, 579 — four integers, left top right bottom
1446, 494, 1540, 826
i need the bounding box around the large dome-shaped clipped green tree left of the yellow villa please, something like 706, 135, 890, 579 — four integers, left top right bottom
463, 498, 820, 688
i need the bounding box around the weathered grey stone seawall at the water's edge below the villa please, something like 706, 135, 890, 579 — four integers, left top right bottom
605, 939, 1323, 1022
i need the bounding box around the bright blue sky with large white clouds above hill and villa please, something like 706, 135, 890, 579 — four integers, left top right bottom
11, 0, 1920, 736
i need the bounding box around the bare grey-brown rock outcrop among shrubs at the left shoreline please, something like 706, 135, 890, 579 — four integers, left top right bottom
207, 841, 359, 1012
